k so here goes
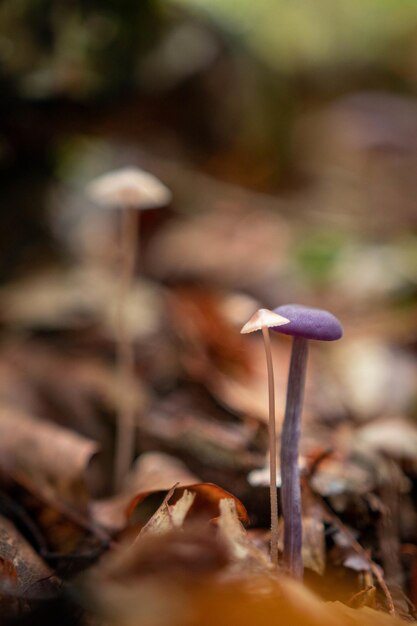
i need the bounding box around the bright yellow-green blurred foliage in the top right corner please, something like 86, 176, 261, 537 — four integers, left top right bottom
175, 0, 417, 77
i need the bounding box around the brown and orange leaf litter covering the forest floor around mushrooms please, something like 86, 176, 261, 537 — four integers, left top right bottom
0, 156, 417, 626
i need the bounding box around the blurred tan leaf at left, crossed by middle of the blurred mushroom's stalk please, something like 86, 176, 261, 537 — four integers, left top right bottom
0, 266, 163, 339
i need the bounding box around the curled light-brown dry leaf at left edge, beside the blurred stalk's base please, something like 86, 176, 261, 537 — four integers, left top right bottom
0, 405, 98, 511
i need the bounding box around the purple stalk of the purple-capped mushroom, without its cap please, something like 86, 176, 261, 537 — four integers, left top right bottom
281, 337, 308, 580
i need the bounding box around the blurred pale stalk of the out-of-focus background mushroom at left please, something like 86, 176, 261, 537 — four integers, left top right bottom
114, 208, 139, 491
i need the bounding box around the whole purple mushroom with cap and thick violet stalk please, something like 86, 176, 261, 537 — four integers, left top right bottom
272, 304, 343, 579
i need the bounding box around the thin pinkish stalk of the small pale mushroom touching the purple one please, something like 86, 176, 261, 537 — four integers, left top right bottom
262, 326, 278, 565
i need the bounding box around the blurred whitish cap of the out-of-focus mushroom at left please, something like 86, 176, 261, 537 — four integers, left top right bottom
87, 167, 172, 209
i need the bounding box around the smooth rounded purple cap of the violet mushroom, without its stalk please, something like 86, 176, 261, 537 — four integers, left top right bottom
271, 304, 343, 341
